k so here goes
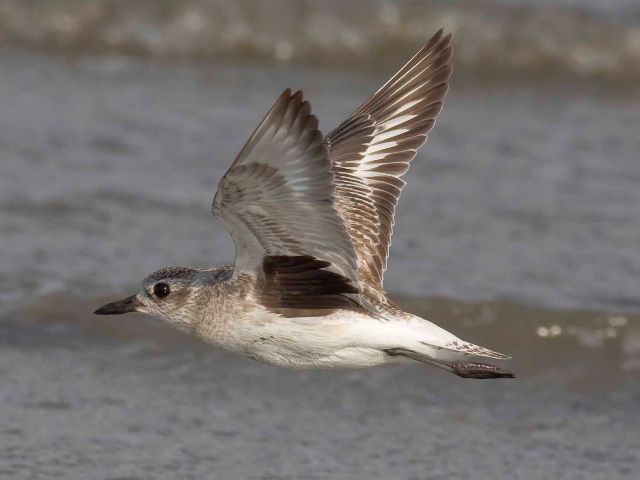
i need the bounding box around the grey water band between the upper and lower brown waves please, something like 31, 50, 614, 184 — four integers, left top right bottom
0, 54, 640, 310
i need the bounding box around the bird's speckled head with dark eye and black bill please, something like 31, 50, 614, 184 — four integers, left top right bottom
94, 267, 207, 328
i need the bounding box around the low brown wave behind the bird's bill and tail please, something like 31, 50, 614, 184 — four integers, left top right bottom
7, 294, 640, 384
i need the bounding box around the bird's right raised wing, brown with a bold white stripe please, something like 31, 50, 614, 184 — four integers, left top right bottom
326, 30, 452, 299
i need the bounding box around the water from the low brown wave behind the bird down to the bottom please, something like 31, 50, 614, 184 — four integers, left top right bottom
0, 295, 640, 480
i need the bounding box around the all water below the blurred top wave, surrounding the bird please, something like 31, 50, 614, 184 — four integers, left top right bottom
0, 24, 640, 480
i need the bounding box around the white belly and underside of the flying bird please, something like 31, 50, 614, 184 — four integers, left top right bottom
198, 309, 470, 368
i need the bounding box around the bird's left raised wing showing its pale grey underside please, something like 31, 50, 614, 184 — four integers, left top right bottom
212, 89, 358, 300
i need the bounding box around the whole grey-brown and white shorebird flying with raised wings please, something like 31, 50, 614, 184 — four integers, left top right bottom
95, 30, 514, 378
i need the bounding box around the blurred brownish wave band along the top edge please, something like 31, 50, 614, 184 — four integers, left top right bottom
0, 0, 640, 80
